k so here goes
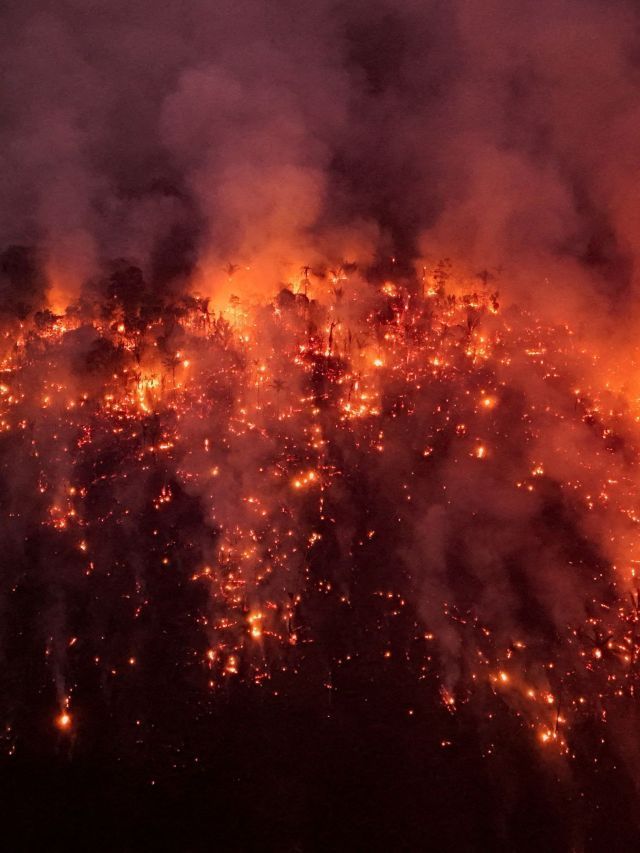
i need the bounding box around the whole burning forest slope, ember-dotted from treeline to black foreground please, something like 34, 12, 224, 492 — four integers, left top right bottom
0, 250, 640, 792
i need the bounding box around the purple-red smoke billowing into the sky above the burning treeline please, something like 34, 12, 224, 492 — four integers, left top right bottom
0, 0, 640, 316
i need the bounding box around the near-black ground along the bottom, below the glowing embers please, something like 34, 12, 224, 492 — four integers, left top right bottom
0, 665, 639, 851
